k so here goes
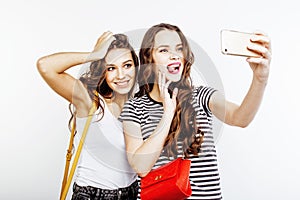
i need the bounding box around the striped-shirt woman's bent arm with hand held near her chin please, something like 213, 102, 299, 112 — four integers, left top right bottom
123, 77, 178, 177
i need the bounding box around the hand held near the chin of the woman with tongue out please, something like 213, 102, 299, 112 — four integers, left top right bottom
158, 71, 178, 116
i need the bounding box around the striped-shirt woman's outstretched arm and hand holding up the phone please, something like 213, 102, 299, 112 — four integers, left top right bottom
209, 33, 271, 127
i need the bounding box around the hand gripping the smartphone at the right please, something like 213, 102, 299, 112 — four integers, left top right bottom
247, 32, 272, 83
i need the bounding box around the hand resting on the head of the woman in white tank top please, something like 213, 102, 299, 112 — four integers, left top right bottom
90, 31, 116, 60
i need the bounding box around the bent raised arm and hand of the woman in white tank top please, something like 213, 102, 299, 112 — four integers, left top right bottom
37, 32, 113, 115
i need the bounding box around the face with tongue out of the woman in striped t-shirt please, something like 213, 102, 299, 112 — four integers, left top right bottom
152, 30, 184, 82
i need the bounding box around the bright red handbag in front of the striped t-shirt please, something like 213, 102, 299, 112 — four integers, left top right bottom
140, 158, 192, 200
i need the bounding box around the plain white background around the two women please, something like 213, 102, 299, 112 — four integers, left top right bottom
0, 0, 300, 200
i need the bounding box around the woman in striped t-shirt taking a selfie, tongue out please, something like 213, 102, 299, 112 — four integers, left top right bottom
120, 23, 271, 200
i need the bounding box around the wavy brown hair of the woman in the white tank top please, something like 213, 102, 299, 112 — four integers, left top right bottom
69, 34, 139, 130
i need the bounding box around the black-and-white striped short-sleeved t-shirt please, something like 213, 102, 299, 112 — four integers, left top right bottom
120, 86, 222, 200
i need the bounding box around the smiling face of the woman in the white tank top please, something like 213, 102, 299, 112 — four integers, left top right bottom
105, 48, 135, 95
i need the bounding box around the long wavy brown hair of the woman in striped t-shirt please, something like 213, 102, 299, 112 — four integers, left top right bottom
135, 23, 204, 157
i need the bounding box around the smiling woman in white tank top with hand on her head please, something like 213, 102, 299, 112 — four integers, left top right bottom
37, 32, 139, 200
